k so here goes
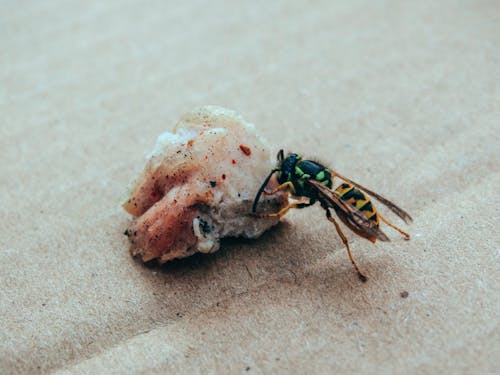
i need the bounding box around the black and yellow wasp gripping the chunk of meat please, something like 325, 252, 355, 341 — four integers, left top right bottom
252, 150, 413, 282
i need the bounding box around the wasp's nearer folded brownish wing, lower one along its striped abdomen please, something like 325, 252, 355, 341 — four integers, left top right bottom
308, 180, 389, 241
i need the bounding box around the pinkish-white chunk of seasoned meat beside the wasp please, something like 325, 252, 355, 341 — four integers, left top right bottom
123, 106, 288, 263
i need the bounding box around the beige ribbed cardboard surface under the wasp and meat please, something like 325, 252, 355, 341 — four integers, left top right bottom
0, 0, 500, 374
